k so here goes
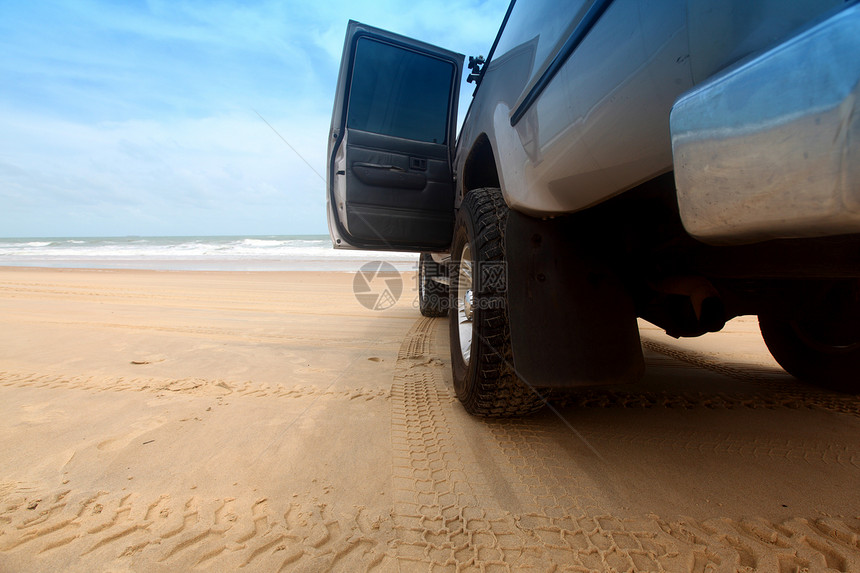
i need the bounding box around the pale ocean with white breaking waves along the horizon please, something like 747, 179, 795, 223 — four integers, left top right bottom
0, 235, 418, 272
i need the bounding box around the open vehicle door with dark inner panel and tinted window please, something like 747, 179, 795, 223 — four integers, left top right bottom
326, 21, 464, 251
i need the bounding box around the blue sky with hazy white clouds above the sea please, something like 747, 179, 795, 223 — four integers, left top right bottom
0, 0, 508, 237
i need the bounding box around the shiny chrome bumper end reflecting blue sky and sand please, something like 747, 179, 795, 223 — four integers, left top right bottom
670, 4, 860, 244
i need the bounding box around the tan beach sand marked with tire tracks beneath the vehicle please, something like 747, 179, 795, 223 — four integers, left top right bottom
0, 268, 860, 572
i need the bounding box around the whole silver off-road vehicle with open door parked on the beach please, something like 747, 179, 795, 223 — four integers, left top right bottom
327, 0, 860, 416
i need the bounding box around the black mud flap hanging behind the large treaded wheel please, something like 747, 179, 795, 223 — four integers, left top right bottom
505, 211, 645, 388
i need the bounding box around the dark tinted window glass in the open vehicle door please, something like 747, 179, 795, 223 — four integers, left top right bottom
347, 38, 454, 143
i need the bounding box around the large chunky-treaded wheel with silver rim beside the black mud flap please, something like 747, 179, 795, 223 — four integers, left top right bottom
449, 188, 545, 417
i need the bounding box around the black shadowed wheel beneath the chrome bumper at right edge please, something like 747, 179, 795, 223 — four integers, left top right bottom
758, 282, 860, 394
